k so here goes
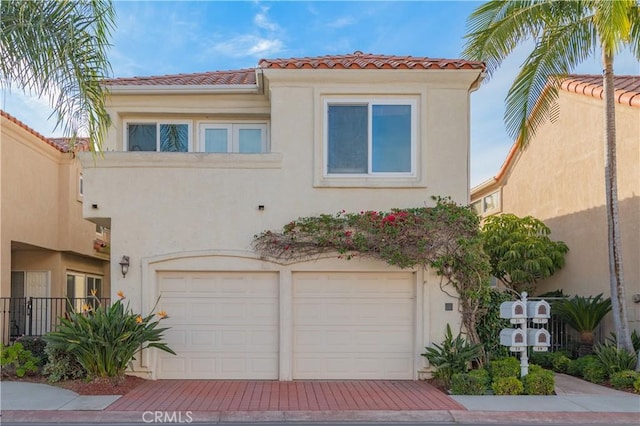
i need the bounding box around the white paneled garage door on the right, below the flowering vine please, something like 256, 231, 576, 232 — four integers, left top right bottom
293, 272, 415, 379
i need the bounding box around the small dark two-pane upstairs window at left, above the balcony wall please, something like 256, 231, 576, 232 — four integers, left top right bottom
125, 122, 191, 152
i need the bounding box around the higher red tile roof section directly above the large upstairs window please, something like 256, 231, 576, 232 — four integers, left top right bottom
258, 51, 485, 70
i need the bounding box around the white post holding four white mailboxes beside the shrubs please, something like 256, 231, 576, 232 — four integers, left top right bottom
500, 291, 551, 377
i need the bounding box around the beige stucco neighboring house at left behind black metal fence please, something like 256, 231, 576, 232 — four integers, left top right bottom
0, 110, 111, 343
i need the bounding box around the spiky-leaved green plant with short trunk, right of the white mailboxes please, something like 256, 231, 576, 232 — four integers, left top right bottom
553, 293, 611, 356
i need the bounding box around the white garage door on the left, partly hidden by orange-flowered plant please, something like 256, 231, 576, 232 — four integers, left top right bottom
157, 272, 279, 379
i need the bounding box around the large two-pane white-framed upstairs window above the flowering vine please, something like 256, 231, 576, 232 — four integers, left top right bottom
324, 100, 416, 176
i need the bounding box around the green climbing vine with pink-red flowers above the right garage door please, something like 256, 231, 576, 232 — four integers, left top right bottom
253, 198, 491, 350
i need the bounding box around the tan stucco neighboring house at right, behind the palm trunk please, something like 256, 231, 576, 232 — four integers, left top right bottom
471, 75, 640, 335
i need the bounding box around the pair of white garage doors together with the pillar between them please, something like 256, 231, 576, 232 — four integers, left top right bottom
155, 271, 416, 379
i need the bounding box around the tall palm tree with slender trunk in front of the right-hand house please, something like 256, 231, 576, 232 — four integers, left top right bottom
463, 0, 640, 351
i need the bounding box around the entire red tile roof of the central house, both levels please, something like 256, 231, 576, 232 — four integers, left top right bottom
103, 51, 485, 86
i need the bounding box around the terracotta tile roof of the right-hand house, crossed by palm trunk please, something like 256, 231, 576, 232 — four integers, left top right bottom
562, 75, 640, 107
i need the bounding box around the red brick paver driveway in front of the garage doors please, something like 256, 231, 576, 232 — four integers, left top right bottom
107, 380, 465, 411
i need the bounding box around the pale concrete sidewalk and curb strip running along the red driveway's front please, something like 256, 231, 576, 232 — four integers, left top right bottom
0, 374, 640, 425
